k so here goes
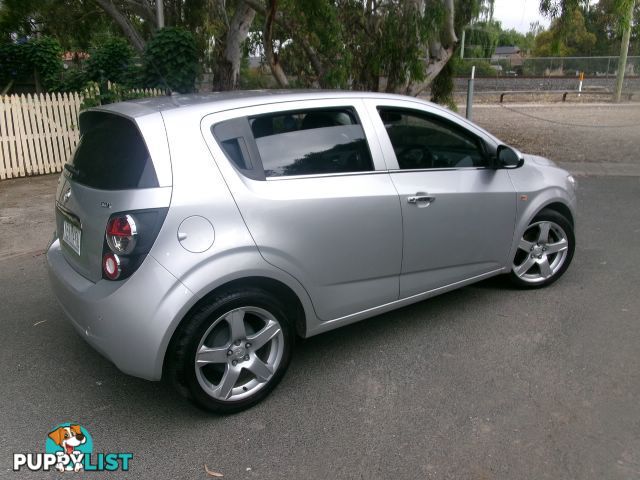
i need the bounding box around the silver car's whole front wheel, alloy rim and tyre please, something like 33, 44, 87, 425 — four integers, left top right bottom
510, 210, 575, 288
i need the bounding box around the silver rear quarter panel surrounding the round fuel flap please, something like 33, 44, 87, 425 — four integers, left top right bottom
151, 109, 315, 343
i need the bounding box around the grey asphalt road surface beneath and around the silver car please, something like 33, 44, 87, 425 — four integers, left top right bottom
0, 106, 640, 480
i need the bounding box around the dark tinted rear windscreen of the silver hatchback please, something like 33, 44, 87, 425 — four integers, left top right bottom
67, 112, 158, 190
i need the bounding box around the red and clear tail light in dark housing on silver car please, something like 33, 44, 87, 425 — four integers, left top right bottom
102, 208, 168, 280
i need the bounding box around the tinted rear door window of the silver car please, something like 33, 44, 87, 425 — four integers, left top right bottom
249, 109, 373, 177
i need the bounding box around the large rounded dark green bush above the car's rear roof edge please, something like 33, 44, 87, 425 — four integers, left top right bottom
144, 27, 198, 93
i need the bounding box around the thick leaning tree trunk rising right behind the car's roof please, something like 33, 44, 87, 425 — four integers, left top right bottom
213, 1, 256, 91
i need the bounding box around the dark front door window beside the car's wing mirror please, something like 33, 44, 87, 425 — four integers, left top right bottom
379, 108, 486, 170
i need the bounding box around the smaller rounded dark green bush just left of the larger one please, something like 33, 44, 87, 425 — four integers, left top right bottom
87, 37, 133, 84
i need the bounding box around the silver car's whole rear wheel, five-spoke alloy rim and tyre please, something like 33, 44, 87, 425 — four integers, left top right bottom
168, 289, 294, 413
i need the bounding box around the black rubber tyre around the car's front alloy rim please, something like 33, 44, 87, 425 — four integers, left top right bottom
509, 209, 576, 289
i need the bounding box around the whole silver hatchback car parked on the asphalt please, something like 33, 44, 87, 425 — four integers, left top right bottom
47, 91, 576, 413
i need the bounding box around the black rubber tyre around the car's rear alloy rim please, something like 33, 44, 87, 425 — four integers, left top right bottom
166, 287, 295, 414
